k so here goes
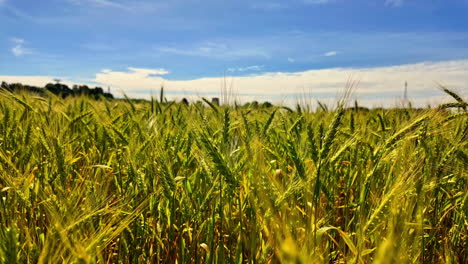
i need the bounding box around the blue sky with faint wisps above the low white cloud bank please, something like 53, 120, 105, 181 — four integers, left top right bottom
0, 0, 468, 106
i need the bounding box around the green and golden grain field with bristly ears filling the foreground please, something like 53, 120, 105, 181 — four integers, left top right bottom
0, 90, 468, 264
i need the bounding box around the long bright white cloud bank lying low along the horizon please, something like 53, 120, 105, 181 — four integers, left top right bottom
0, 60, 468, 107
